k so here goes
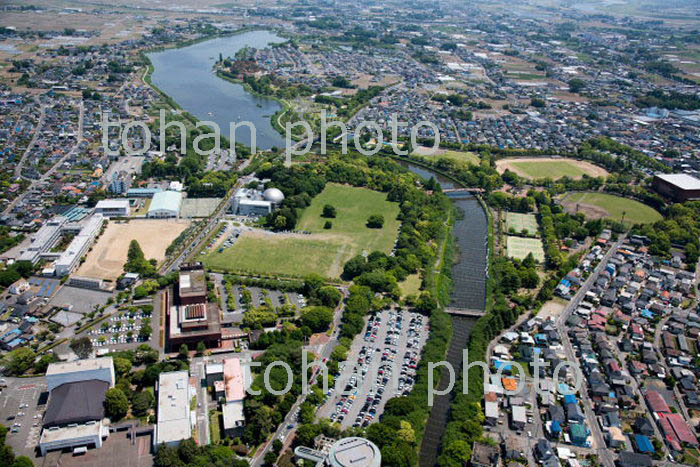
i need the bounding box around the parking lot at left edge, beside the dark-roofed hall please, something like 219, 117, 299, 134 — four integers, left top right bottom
0, 378, 47, 458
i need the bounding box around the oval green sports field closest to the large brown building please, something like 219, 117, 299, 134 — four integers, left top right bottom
562, 193, 661, 224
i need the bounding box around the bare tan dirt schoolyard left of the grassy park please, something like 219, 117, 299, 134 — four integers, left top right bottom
77, 219, 190, 281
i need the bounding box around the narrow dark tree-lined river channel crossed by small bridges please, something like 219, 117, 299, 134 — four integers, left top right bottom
401, 162, 488, 467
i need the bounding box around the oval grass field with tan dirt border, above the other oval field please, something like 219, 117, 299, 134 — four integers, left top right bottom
496, 157, 608, 180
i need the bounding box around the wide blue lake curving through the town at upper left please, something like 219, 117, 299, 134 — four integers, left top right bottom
148, 31, 285, 149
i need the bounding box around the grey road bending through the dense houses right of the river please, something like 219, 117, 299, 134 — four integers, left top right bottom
556, 236, 626, 467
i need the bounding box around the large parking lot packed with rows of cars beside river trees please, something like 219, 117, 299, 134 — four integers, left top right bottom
319, 309, 429, 428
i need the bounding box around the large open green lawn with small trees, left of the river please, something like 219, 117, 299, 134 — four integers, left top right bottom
204, 184, 400, 279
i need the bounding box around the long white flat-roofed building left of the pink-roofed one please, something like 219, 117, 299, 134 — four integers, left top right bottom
153, 371, 194, 449
